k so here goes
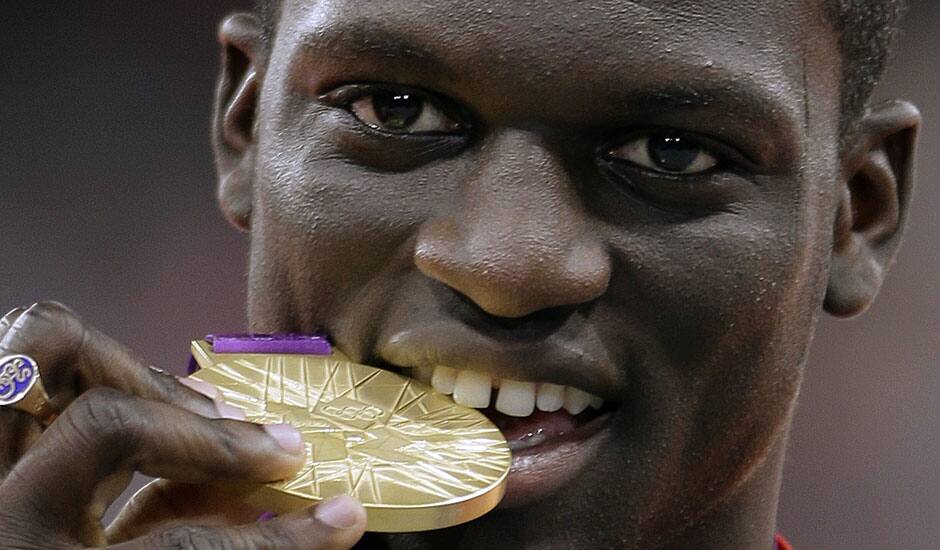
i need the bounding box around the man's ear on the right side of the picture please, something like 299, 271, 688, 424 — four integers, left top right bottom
824, 101, 921, 317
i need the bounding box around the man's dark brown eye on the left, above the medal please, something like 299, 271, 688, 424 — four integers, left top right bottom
349, 91, 463, 134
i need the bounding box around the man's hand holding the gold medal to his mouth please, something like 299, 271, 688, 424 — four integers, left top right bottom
0, 303, 365, 549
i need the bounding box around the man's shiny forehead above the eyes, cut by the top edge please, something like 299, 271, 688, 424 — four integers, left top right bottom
278, 0, 839, 144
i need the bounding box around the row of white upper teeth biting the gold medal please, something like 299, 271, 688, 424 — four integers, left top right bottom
412, 366, 604, 417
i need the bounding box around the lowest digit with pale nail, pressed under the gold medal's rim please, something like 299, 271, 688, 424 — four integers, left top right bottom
111, 496, 366, 550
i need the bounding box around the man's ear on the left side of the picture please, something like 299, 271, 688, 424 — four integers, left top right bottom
212, 13, 266, 231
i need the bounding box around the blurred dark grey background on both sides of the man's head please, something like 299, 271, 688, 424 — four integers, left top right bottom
0, 0, 940, 550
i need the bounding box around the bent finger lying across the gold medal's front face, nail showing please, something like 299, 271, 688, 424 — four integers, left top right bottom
0, 388, 305, 533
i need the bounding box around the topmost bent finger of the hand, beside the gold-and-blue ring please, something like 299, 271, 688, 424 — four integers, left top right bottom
0, 302, 218, 416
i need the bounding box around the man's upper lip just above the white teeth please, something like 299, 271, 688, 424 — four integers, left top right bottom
374, 321, 624, 401
